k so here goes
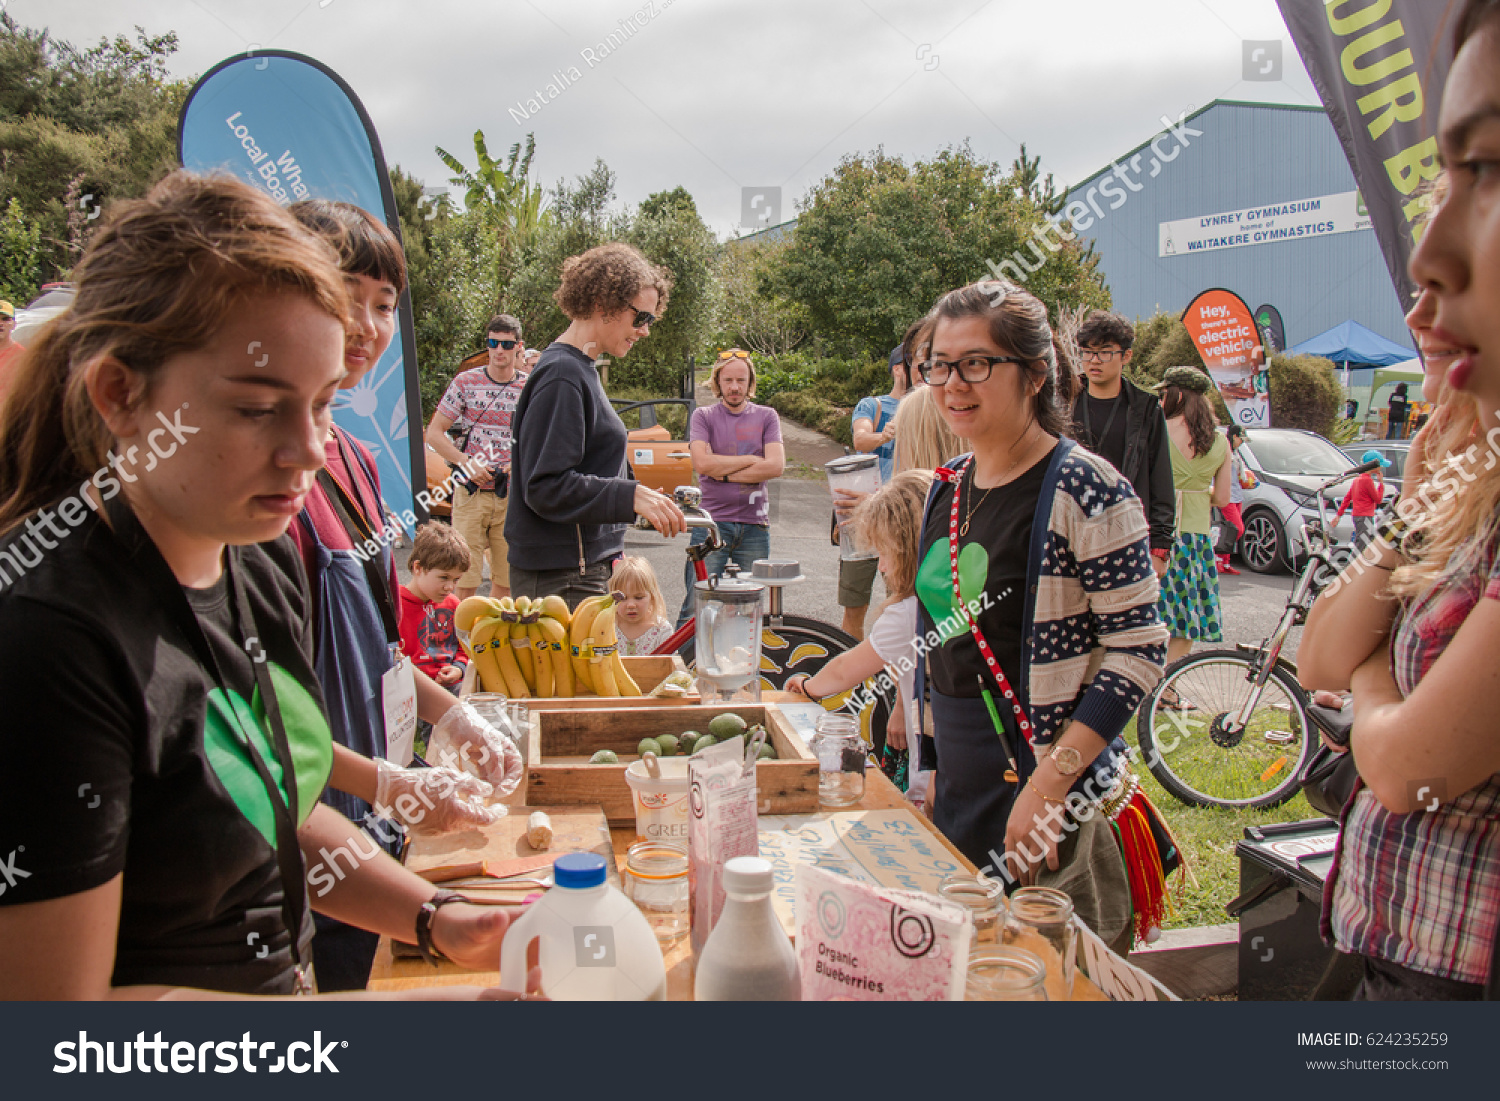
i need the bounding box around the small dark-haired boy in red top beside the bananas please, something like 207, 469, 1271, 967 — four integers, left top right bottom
399, 521, 470, 693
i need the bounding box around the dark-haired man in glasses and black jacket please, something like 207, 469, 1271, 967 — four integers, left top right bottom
1073, 309, 1178, 578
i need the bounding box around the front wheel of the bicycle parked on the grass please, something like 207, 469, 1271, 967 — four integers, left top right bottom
1136, 650, 1317, 807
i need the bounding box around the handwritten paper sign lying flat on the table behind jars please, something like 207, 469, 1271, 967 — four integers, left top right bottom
759, 810, 963, 936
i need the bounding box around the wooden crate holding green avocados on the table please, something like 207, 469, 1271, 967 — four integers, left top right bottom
527, 701, 818, 825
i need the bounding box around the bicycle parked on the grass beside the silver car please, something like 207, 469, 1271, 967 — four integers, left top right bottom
1136, 462, 1376, 809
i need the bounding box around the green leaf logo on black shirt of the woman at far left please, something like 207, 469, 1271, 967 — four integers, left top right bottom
203, 662, 333, 849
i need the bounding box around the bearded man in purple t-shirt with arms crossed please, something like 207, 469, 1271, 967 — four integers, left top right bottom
677, 348, 786, 626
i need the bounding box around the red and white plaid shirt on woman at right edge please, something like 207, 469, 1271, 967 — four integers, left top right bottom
1323, 525, 1500, 983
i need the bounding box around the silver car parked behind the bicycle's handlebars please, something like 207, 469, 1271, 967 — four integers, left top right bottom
1239, 428, 1395, 573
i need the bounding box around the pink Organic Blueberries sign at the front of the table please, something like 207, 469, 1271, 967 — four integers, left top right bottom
797, 864, 974, 1002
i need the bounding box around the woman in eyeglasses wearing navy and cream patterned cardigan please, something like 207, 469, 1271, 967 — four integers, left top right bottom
917, 282, 1167, 947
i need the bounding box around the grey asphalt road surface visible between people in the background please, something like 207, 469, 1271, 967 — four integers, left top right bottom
398, 474, 1301, 659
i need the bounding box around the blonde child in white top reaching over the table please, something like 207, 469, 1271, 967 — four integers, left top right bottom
786, 470, 933, 798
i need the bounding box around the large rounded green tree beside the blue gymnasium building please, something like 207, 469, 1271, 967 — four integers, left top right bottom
761, 144, 1110, 356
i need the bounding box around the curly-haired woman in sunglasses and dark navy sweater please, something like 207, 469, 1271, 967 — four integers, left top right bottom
506, 242, 686, 608
